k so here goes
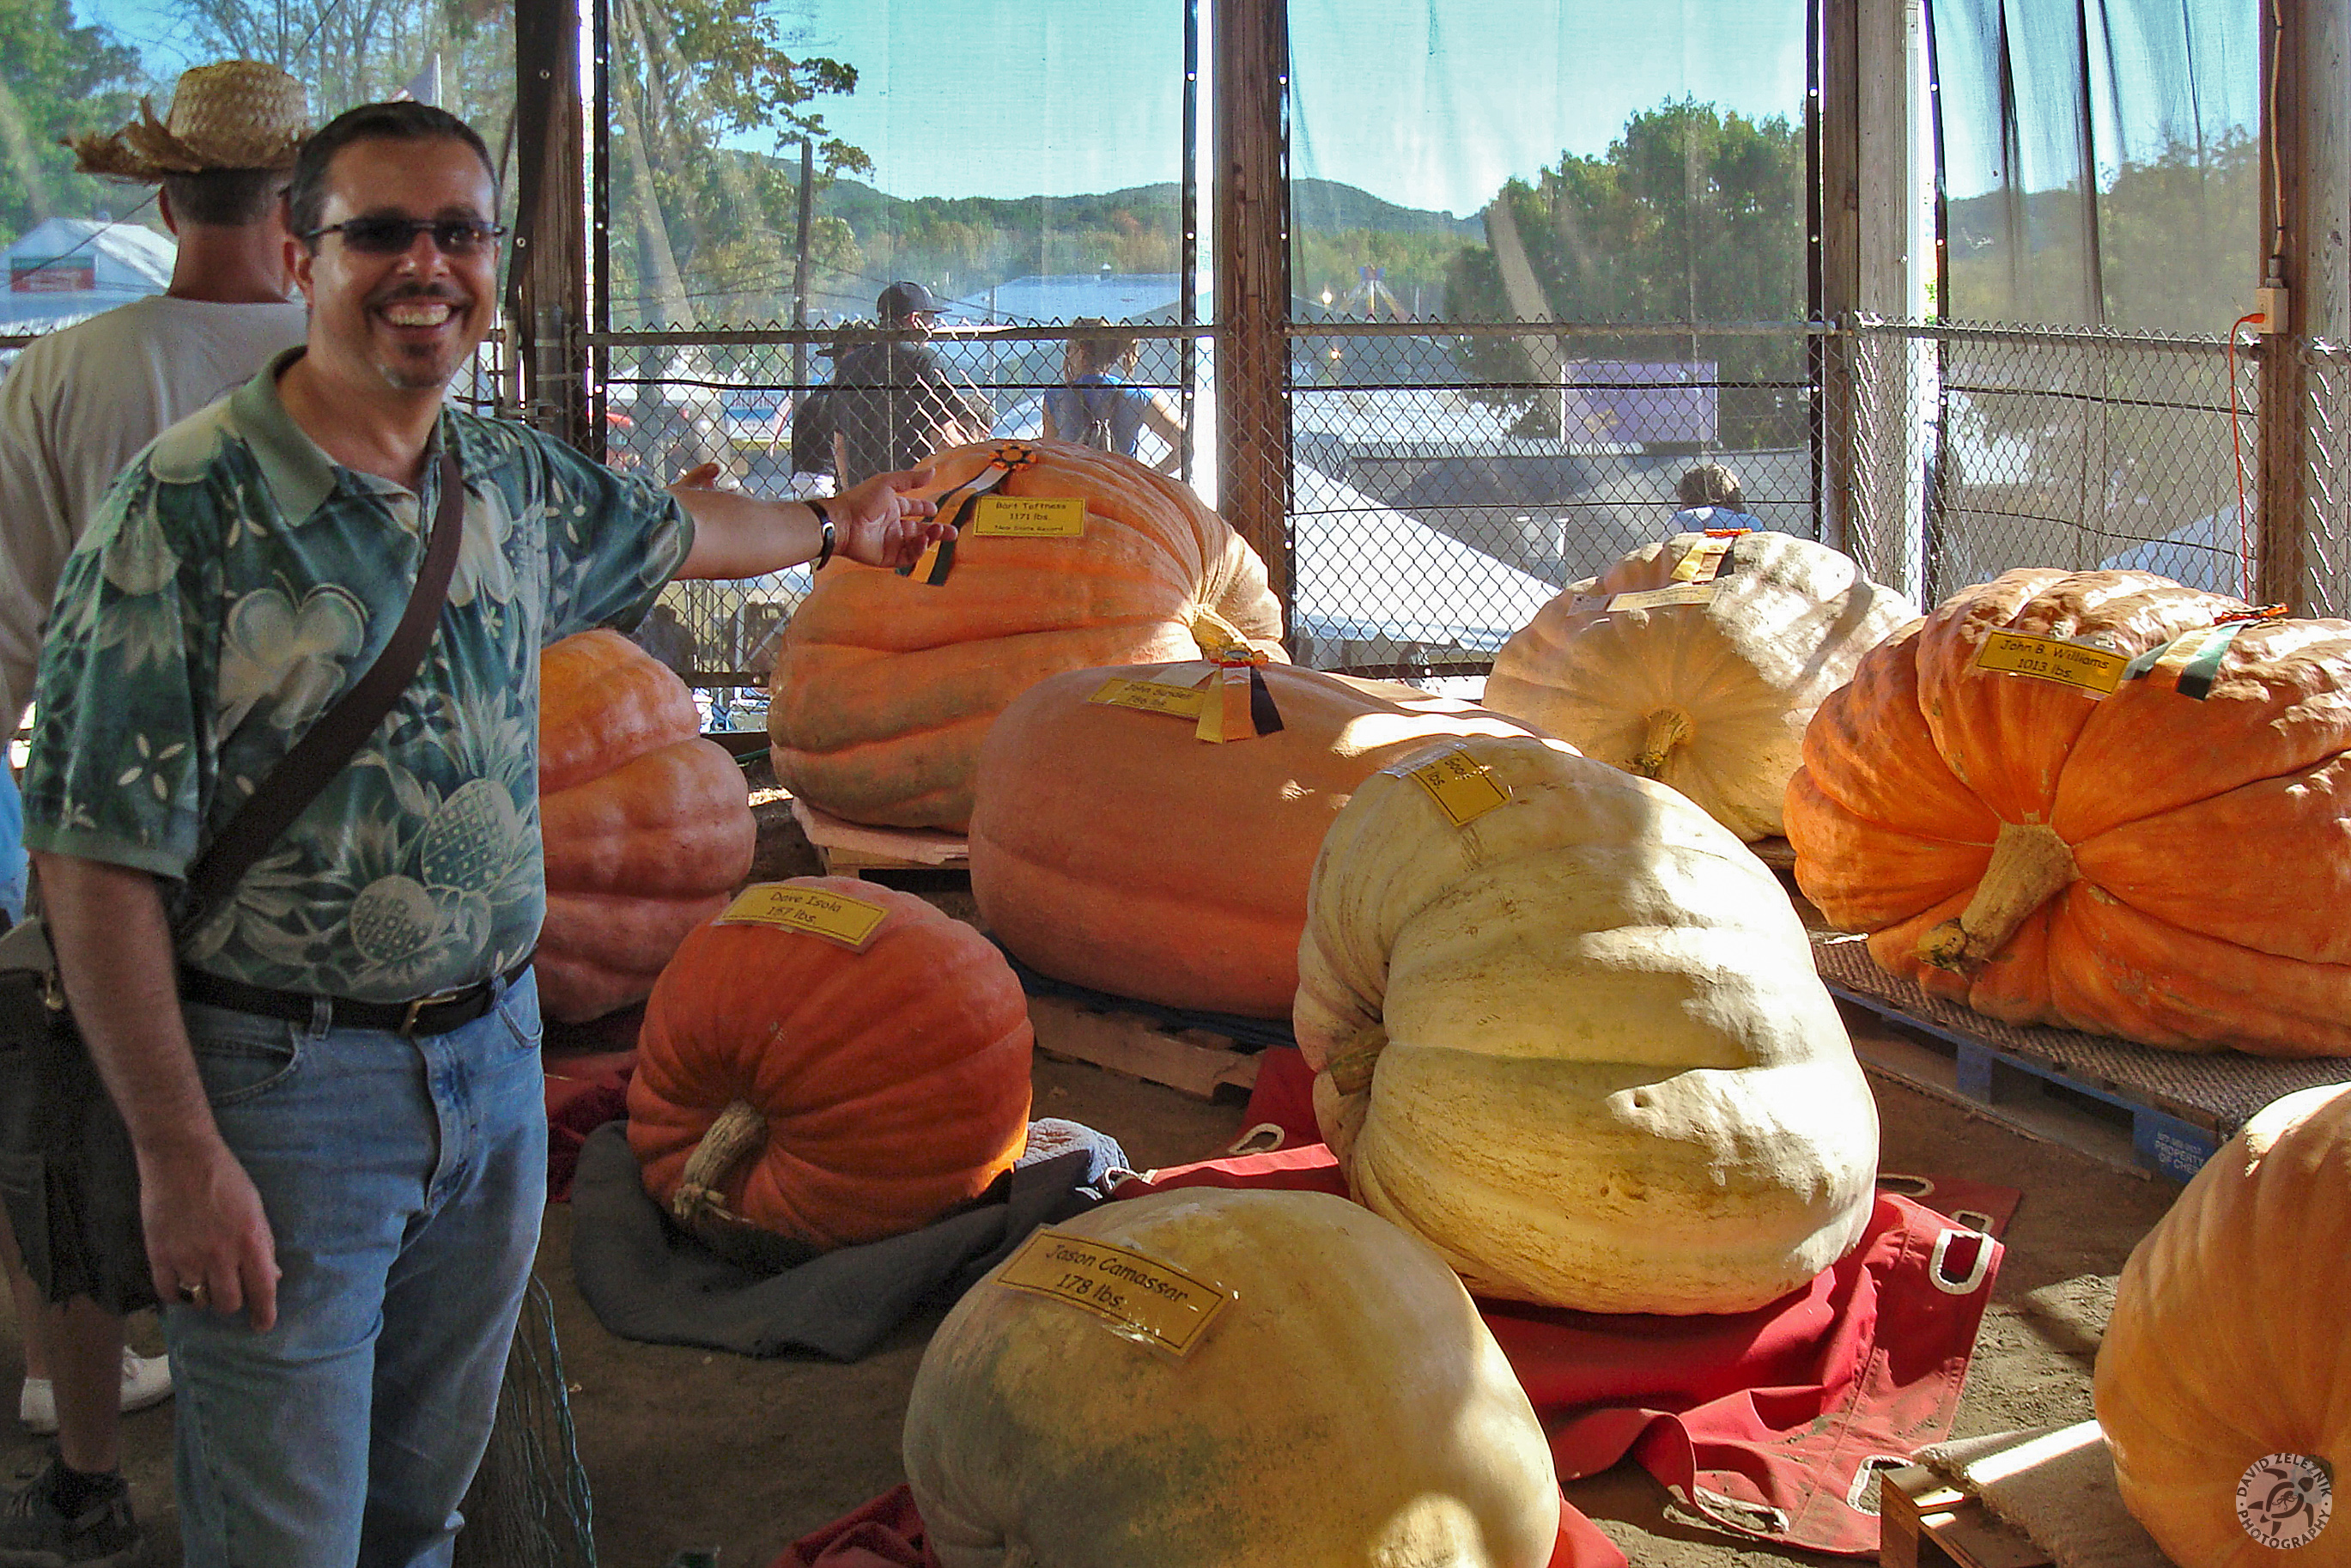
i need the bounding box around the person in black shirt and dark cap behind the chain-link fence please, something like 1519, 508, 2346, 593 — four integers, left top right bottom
793, 283, 994, 489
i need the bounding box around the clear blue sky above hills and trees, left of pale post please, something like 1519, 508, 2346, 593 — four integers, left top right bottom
76, 0, 1803, 214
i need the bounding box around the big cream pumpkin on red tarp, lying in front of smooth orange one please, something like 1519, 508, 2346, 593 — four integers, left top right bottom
1293, 738, 1879, 1314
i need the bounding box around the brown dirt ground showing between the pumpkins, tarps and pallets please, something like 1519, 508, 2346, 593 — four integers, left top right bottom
0, 804, 2177, 1568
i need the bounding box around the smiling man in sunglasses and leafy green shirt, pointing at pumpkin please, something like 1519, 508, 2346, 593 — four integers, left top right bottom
26, 103, 945, 1568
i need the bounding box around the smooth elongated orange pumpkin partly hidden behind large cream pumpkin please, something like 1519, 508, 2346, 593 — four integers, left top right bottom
971, 665, 1533, 1018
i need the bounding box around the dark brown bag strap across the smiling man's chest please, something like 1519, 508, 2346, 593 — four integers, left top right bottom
179, 447, 465, 931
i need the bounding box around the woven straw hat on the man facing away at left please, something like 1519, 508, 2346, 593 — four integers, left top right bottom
68, 58, 310, 181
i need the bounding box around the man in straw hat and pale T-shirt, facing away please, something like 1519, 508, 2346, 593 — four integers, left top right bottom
0, 61, 310, 1564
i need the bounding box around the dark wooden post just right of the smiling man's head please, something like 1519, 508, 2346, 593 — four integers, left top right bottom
506, 0, 604, 459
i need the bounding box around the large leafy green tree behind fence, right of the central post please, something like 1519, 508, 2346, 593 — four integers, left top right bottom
1446, 99, 1806, 444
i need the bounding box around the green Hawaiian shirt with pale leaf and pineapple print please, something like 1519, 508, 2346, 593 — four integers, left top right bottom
23, 350, 694, 1001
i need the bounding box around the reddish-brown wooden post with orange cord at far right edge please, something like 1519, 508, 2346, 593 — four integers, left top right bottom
2255, 0, 2351, 616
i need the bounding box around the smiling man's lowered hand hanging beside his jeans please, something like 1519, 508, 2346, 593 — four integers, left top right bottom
139, 1135, 280, 1330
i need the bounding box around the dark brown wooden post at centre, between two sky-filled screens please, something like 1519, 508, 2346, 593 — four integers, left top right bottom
1211, 0, 1296, 635
